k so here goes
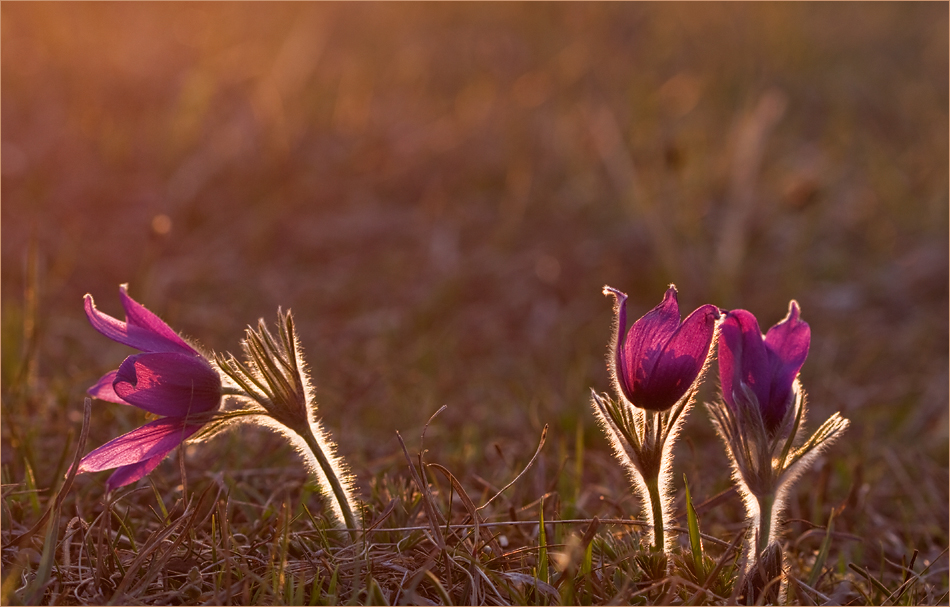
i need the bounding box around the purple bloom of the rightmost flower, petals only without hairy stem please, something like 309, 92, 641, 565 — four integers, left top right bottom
719, 300, 811, 433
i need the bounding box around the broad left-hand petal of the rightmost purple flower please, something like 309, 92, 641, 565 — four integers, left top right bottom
719, 310, 771, 407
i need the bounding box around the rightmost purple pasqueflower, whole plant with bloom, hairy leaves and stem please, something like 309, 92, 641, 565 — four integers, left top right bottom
706, 300, 849, 602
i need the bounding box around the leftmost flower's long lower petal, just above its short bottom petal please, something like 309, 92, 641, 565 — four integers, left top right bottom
77, 417, 202, 482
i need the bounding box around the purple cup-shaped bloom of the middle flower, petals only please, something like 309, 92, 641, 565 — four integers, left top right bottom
604, 285, 719, 411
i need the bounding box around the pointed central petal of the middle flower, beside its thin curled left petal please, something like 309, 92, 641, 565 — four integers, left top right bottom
620, 285, 680, 404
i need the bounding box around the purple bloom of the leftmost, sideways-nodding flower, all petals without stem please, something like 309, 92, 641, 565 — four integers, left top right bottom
78, 285, 221, 491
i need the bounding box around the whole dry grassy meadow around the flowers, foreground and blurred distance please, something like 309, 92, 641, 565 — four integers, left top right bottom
0, 3, 950, 605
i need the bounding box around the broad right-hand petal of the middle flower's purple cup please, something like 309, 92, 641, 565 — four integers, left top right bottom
633, 304, 719, 411
